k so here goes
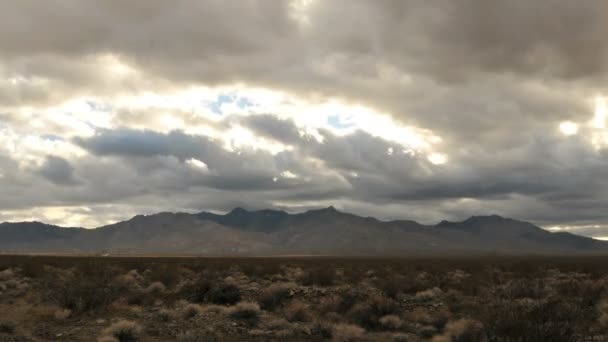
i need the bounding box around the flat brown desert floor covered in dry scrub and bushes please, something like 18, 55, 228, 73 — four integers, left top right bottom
0, 255, 608, 342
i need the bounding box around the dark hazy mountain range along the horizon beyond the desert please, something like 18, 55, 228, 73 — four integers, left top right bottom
0, 207, 608, 256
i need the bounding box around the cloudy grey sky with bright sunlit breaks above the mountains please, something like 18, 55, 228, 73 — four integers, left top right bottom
0, 0, 608, 238
